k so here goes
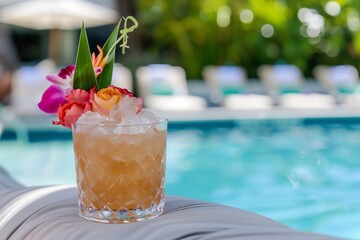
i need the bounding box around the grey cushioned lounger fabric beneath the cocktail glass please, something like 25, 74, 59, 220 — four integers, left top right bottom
0, 168, 338, 240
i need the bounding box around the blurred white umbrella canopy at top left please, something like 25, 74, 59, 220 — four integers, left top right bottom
0, 0, 119, 30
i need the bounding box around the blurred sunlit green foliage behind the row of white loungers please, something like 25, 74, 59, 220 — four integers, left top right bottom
136, 0, 360, 78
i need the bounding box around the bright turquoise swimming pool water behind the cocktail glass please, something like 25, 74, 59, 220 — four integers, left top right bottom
0, 119, 360, 239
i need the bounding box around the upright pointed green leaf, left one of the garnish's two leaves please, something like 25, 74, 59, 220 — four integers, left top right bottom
74, 23, 98, 91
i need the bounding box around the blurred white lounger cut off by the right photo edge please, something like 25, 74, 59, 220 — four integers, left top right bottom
314, 65, 360, 106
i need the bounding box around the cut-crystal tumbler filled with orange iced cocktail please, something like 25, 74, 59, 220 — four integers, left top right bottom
73, 120, 167, 223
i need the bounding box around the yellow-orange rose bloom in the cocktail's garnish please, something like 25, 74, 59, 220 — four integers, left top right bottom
90, 86, 121, 114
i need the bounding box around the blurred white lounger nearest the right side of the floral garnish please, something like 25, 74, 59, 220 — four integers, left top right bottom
136, 64, 207, 111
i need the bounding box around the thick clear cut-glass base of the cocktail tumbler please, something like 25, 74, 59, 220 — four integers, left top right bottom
79, 201, 164, 223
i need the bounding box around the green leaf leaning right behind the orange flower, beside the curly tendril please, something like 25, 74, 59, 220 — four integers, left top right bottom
97, 22, 120, 90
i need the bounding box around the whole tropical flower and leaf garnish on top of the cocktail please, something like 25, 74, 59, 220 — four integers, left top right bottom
38, 16, 142, 129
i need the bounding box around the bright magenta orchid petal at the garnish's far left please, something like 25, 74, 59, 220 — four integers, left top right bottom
38, 85, 66, 113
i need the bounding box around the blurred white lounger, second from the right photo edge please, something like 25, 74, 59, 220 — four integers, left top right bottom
258, 65, 335, 109
